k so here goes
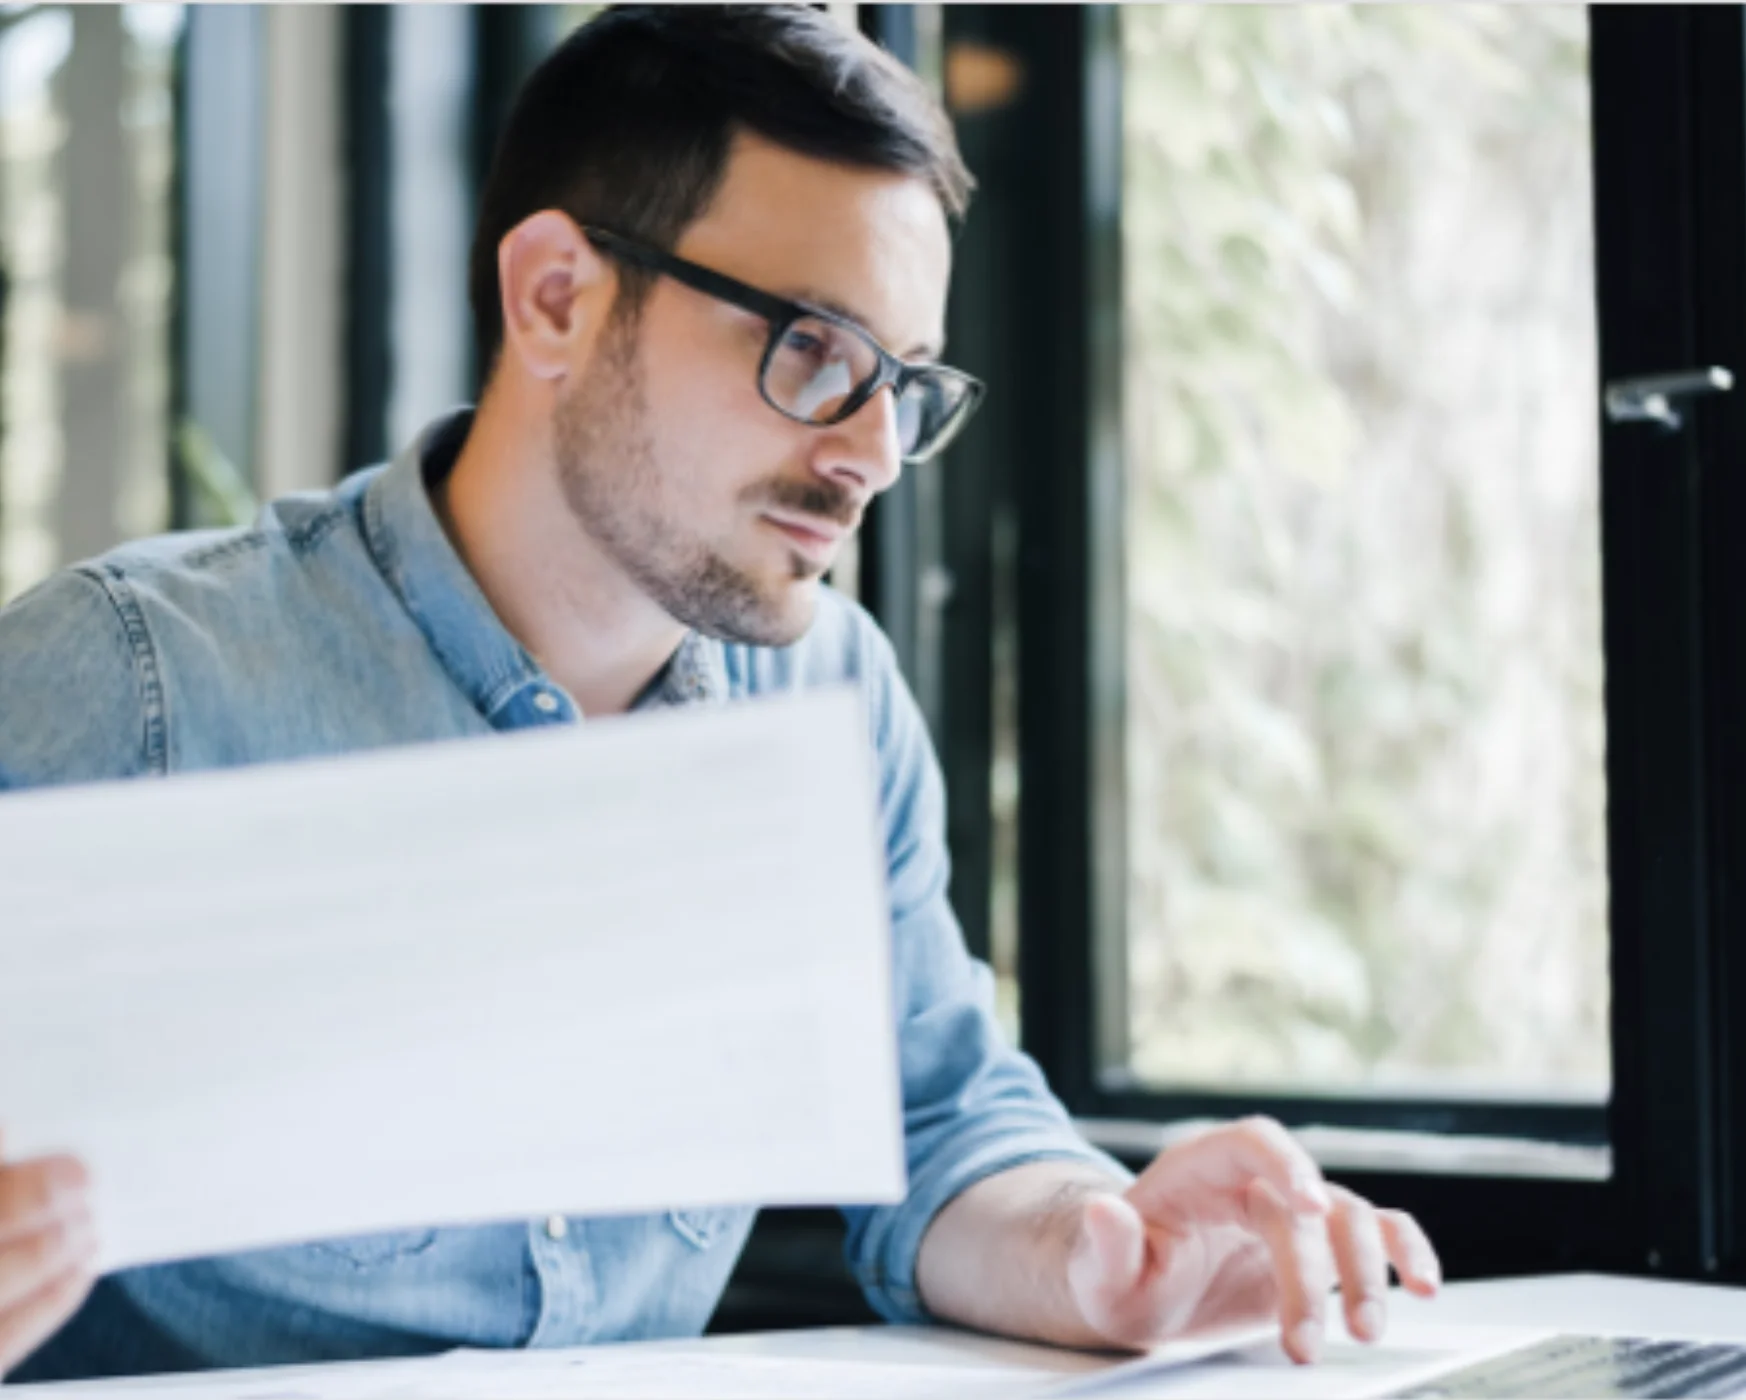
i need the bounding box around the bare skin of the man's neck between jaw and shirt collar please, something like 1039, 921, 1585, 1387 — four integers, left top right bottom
431, 405, 684, 714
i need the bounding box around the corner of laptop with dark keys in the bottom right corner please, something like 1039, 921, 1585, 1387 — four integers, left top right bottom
1392, 1337, 1746, 1400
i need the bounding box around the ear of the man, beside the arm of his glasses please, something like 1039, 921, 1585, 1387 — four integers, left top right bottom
498, 209, 616, 379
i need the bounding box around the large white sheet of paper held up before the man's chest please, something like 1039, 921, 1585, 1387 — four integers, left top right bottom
0, 690, 904, 1269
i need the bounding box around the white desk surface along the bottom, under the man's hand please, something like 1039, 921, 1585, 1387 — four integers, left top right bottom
17, 1274, 1746, 1400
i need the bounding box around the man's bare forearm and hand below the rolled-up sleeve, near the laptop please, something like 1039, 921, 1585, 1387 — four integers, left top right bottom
917, 1119, 1442, 1362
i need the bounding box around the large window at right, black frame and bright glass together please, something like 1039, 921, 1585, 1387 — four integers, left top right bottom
936, 5, 1746, 1276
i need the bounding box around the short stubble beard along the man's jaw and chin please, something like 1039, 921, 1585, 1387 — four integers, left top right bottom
553, 309, 814, 646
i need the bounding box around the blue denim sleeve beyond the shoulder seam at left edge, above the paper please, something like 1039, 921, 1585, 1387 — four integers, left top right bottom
0, 569, 164, 793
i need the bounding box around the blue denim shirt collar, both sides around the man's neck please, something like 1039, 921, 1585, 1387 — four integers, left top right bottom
363, 408, 726, 728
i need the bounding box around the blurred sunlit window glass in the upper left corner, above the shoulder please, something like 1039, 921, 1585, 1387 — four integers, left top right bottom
0, 5, 182, 600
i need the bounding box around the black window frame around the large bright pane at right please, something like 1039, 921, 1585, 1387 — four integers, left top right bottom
938, 5, 1746, 1278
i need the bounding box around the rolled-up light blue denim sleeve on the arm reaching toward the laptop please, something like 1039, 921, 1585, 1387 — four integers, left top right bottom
843, 623, 1130, 1321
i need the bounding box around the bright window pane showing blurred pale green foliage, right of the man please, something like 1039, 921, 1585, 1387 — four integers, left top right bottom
1121, 5, 1608, 1098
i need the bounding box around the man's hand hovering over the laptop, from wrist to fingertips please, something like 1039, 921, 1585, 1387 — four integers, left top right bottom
1067, 1119, 1442, 1362
